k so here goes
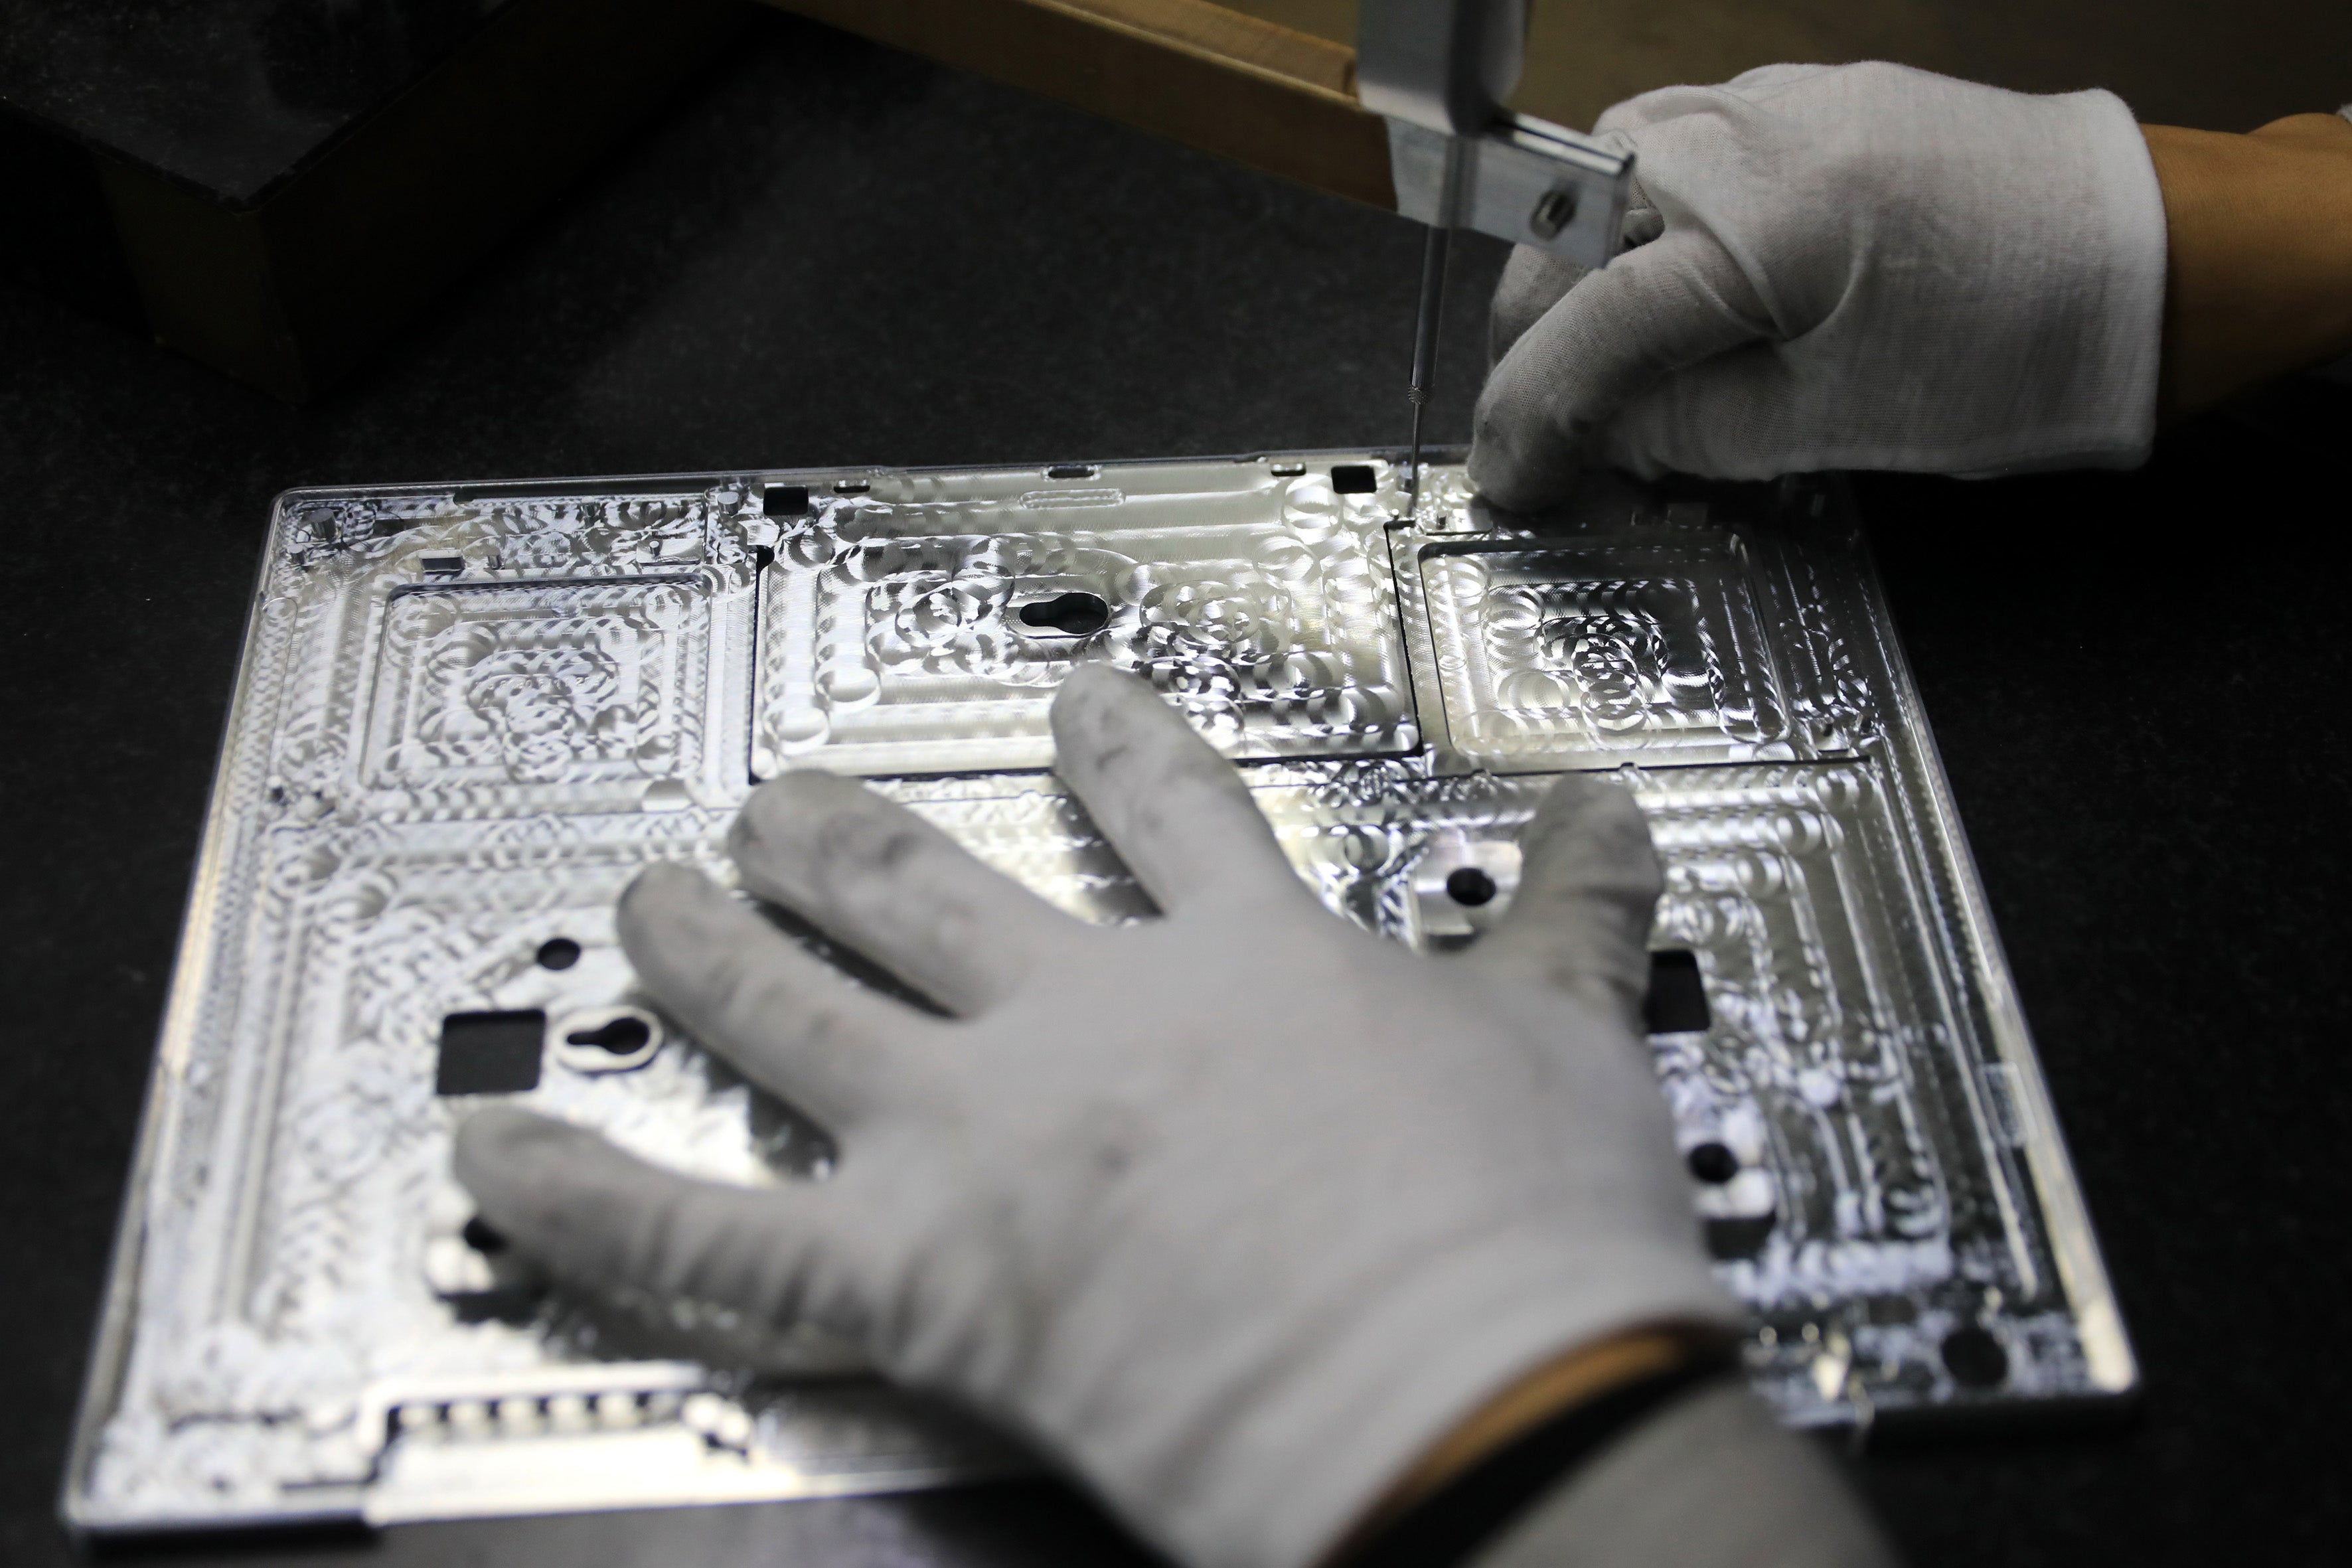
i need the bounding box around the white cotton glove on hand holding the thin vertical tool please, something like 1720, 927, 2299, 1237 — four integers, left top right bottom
1470, 64, 2164, 508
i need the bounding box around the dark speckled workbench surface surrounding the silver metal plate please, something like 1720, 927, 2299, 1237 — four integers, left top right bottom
0, 21, 2352, 1568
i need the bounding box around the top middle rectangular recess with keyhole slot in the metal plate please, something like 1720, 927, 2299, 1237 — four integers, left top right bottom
753, 463, 1421, 778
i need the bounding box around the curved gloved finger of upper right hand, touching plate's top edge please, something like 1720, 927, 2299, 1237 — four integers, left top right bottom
1470, 226, 1768, 510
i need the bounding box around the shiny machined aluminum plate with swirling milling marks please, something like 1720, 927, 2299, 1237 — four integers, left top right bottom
66, 453, 2136, 1530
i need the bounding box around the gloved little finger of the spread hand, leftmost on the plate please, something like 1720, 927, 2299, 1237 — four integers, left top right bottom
456, 1107, 842, 1324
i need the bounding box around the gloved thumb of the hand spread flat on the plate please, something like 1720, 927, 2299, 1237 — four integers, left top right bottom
1465, 773, 1665, 1034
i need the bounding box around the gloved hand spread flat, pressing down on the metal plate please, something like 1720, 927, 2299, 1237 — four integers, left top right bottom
456, 665, 1738, 1568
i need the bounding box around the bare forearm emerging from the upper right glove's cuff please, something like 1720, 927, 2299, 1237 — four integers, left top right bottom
2143, 116, 2352, 418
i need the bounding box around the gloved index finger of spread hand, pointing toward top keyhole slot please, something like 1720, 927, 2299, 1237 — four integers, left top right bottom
1054, 665, 1305, 912
